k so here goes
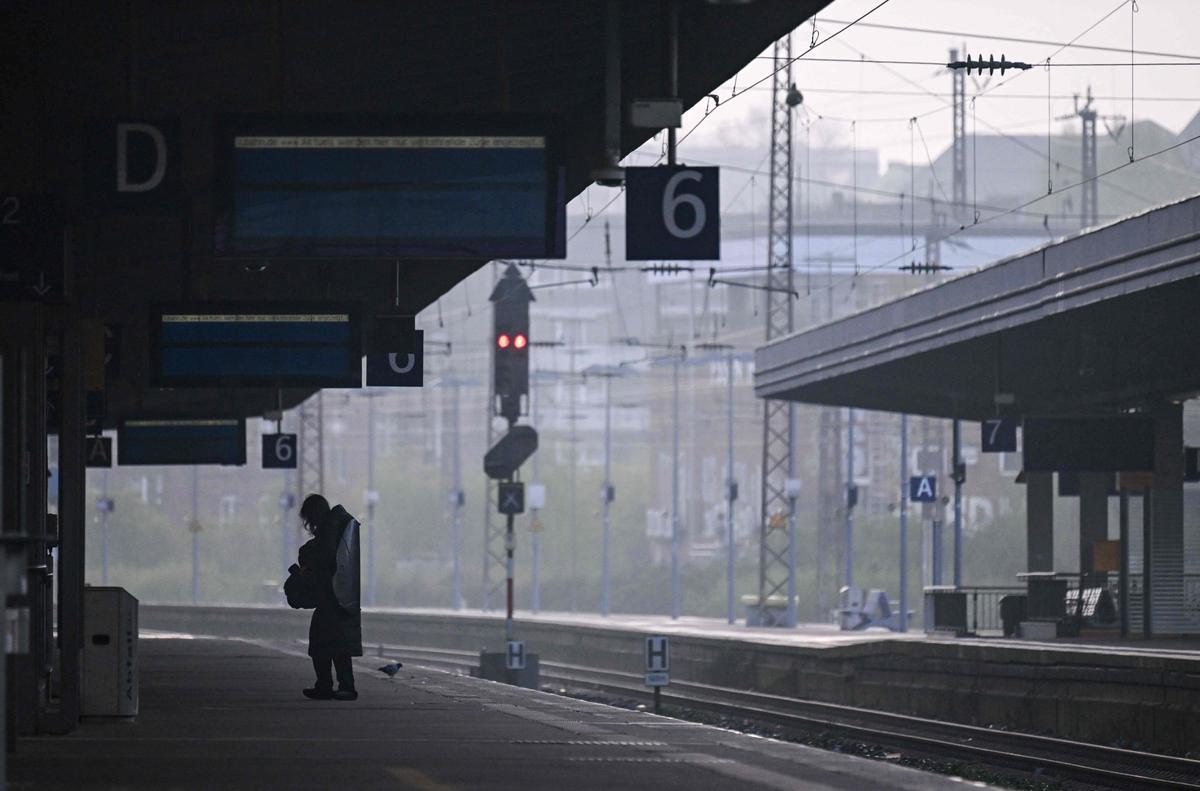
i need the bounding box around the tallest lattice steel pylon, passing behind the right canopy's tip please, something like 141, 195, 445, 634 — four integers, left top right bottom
758, 35, 796, 627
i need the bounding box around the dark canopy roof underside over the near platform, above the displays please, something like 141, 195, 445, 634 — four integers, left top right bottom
0, 0, 828, 423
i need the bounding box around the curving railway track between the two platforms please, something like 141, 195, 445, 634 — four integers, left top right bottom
384, 646, 1200, 791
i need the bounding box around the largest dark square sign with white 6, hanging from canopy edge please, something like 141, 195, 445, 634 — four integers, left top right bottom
625, 166, 721, 260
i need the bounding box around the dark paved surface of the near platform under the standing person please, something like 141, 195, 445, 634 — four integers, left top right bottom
8, 633, 979, 791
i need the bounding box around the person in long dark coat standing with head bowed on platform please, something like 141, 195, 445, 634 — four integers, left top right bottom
289, 495, 362, 700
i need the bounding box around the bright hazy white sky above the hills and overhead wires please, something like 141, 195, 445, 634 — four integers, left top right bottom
649, 0, 1200, 169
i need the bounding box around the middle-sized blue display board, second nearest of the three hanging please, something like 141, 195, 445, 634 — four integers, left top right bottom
150, 302, 362, 388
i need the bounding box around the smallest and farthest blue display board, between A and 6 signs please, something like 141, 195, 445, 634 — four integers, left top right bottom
116, 418, 246, 466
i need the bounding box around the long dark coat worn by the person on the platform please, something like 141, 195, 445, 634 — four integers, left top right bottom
300, 505, 362, 657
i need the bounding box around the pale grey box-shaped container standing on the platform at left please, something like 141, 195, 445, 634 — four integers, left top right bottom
83, 587, 138, 717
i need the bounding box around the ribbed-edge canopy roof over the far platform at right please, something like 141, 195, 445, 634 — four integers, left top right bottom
755, 197, 1200, 419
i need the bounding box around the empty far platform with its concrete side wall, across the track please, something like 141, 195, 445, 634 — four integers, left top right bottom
140, 605, 1200, 755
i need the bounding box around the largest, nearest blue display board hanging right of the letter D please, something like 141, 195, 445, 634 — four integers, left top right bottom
214, 116, 565, 258
